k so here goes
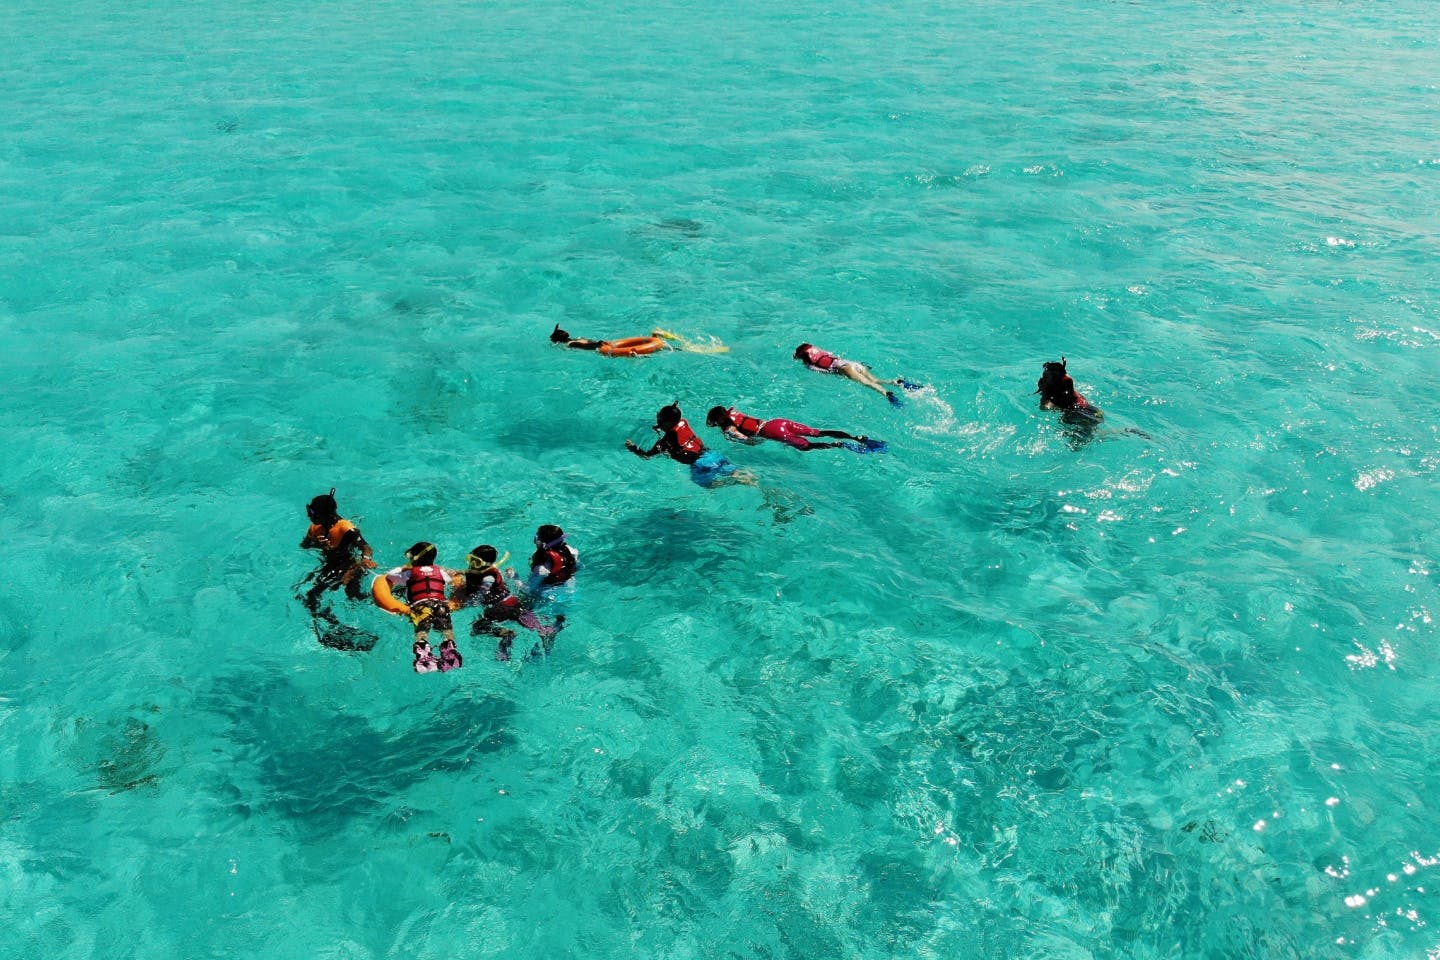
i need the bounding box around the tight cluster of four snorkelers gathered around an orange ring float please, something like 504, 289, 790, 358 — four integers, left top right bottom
300, 489, 580, 674
